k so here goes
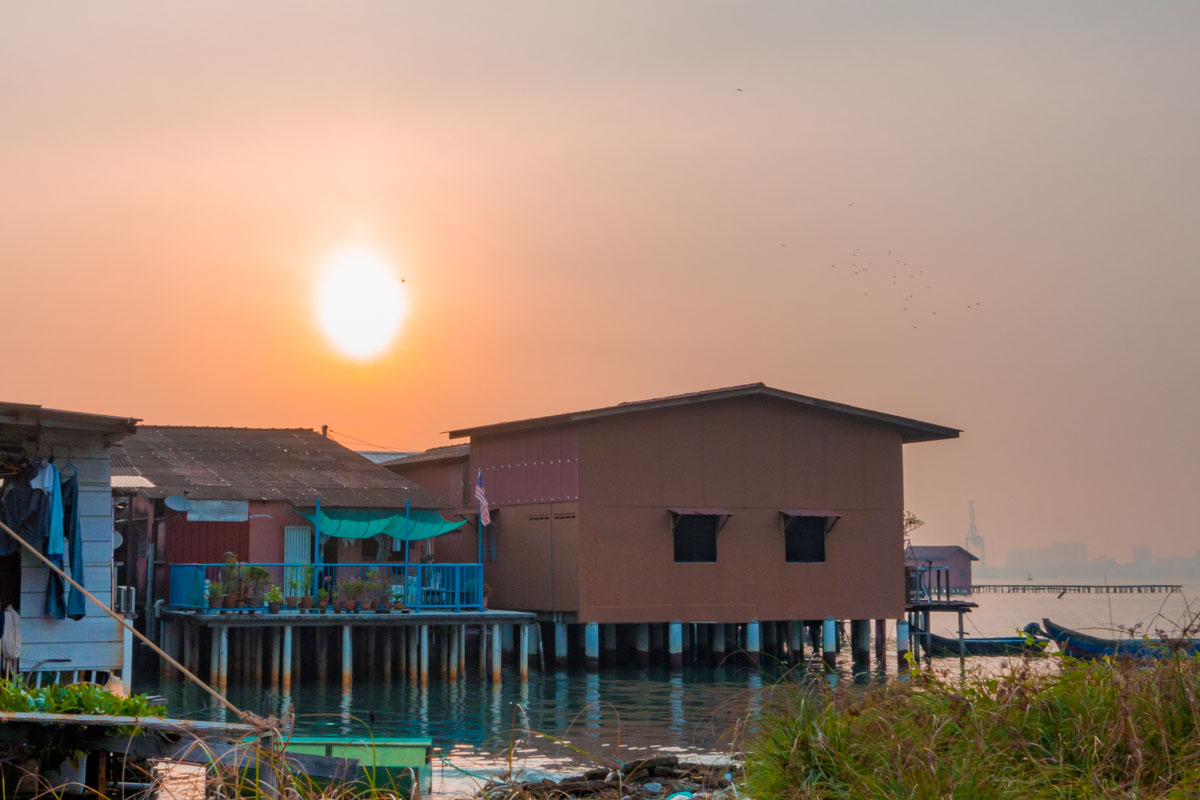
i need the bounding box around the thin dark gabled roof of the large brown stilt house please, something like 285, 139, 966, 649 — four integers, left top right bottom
449, 384, 961, 443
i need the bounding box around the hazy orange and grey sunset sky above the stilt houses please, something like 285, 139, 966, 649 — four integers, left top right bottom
0, 0, 1200, 561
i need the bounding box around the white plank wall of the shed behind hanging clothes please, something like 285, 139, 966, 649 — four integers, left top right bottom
20, 434, 122, 670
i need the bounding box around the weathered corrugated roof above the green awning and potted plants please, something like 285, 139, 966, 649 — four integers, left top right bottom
121, 426, 449, 509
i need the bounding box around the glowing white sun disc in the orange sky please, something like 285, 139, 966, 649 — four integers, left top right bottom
317, 248, 407, 361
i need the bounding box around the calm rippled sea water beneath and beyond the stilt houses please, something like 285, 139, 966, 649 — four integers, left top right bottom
137, 585, 1200, 796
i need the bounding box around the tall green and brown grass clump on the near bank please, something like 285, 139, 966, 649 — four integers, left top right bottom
746, 658, 1200, 800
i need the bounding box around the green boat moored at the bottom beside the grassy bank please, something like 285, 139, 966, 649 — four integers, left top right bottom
255, 736, 433, 799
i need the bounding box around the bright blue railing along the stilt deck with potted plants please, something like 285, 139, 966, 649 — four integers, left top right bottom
168, 563, 484, 610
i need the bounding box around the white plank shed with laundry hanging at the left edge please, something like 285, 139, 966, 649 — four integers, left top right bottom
0, 403, 138, 684
